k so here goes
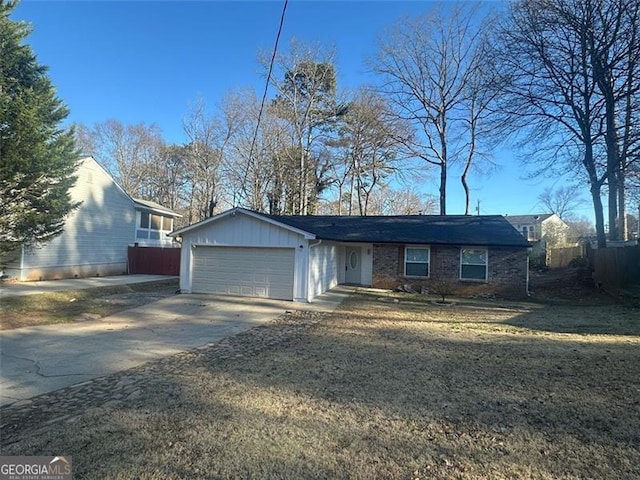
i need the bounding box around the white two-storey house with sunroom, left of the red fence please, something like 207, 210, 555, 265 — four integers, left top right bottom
2, 157, 180, 281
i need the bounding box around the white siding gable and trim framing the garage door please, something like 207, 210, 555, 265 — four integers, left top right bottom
180, 211, 309, 301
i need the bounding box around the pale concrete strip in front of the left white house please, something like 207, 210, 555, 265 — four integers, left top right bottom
0, 275, 178, 299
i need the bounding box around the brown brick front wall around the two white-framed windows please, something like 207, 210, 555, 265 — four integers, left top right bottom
372, 244, 528, 297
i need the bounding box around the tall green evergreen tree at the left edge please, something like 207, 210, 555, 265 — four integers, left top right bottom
0, 0, 78, 254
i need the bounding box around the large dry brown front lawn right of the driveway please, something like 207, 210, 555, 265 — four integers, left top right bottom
2, 294, 640, 479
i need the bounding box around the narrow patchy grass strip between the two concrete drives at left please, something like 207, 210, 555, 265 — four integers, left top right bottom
0, 279, 178, 330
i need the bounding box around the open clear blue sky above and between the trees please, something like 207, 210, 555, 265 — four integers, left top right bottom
12, 0, 593, 218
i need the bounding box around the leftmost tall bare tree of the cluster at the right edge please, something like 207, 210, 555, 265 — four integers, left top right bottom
493, 0, 607, 246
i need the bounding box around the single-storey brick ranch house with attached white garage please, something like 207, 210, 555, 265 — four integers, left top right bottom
171, 208, 531, 301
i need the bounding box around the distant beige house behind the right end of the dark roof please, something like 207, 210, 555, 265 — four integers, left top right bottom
505, 213, 569, 265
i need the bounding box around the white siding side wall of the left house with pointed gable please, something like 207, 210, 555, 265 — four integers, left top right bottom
6, 157, 135, 280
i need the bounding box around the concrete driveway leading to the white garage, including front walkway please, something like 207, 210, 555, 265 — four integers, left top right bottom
0, 287, 351, 405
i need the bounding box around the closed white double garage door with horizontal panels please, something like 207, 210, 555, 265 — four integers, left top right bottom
191, 246, 294, 300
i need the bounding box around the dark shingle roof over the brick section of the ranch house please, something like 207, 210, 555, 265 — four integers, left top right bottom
260, 214, 531, 248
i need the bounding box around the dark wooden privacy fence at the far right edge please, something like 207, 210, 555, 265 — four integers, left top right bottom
590, 245, 640, 295
